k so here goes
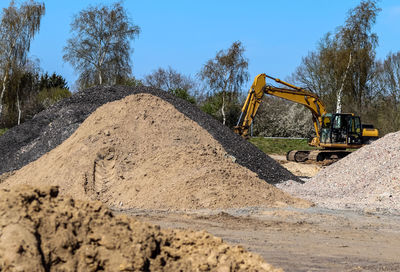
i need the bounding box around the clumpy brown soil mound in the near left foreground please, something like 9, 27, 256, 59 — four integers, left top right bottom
0, 187, 282, 272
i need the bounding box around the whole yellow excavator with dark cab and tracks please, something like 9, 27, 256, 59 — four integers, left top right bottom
234, 74, 379, 162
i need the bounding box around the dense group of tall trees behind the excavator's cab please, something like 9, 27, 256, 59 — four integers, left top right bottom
291, 1, 400, 135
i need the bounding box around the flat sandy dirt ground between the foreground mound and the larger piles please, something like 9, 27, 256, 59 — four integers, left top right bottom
124, 208, 400, 272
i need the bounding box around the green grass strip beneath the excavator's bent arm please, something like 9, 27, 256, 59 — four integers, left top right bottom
249, 137, 316, 155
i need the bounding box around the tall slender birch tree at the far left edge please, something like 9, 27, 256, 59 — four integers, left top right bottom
0, 0, 45, 123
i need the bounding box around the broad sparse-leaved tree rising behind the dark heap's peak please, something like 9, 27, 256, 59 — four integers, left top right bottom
63, 2, 140, 87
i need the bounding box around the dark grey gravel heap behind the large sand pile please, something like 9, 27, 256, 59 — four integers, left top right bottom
0, 86, 297, 184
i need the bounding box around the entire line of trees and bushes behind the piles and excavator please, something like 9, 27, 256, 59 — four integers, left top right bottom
0, 0, 400, 137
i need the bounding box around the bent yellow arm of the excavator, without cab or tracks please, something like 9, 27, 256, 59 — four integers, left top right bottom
235, 74, 327, 146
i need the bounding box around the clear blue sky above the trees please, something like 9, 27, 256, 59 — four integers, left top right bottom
0, 0, 400, 91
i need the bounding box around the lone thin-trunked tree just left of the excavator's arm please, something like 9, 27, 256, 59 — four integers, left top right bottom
199, 41, 249, 125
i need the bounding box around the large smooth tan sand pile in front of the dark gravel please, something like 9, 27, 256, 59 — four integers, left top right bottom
0, 93, 310, 210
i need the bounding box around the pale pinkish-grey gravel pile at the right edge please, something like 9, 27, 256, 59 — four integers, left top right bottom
278, 131, 400, 213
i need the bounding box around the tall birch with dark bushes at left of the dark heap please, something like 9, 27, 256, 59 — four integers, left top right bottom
0, 1, 71, 128
